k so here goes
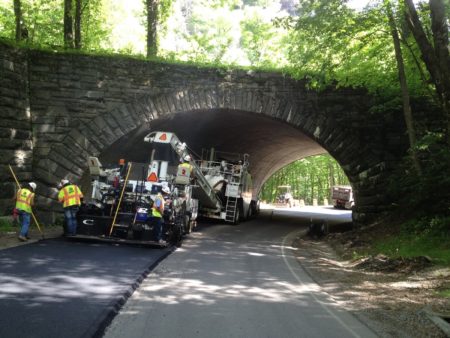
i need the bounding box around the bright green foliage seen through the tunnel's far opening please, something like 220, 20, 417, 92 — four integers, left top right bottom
260, 155, 349, 204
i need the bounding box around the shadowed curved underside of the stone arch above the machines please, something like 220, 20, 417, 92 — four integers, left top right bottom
100, 109, 326, 194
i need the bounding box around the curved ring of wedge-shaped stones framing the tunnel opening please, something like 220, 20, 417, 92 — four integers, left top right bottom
34, 86, 398, 226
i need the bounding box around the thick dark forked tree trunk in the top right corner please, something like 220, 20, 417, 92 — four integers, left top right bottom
403, 0, 450, 145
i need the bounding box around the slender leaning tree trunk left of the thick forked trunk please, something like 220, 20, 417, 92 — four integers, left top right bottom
385, 0, 422, 175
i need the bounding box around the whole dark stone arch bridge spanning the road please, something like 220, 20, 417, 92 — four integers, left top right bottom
0, 45, 406, 223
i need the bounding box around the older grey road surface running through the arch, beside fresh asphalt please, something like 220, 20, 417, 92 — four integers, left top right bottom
105, 208, 375, 337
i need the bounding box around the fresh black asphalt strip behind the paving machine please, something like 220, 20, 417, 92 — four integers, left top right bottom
0, 238, 171, 338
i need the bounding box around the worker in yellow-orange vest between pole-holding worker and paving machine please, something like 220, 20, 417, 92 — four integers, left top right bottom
58, 179, 83, 236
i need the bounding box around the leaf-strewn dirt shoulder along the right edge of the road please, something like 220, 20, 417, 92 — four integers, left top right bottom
294, 237, 450, 337
